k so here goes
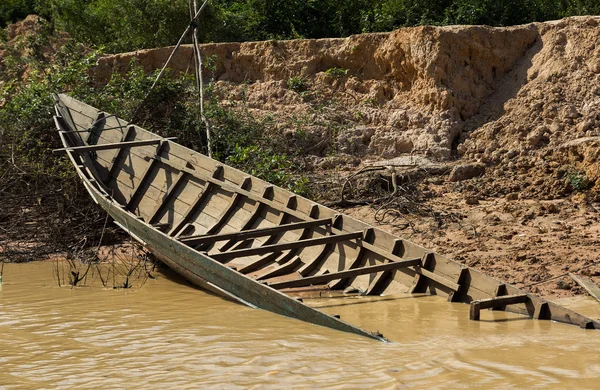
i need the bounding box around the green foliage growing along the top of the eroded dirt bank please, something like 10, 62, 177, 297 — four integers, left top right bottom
0, 0, 600, 52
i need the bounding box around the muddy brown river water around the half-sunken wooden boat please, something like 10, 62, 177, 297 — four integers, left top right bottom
0, 262, 600, 389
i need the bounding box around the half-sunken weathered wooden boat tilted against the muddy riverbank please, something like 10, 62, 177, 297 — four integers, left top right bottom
55, 95, 600, 340
